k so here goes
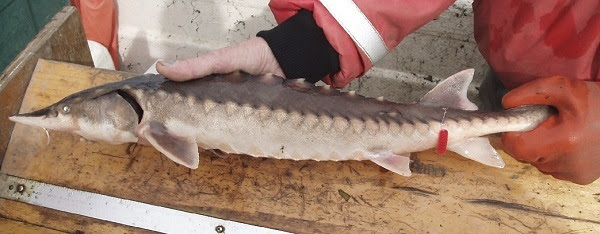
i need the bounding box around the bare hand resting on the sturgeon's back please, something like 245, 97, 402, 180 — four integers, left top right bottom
156, 37, 284, 81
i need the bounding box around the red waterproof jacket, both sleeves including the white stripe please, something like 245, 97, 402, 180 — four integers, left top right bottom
269, 0, 600, 88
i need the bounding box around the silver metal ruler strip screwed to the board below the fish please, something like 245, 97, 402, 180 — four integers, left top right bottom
0, 173, 286, 233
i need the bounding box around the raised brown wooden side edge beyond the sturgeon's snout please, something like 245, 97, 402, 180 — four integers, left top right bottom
0, 6, 94, 163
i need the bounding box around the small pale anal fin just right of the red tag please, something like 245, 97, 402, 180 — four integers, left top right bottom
448, 137, 504, 168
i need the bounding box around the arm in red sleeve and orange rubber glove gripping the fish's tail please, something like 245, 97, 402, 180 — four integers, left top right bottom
473, 0, 600, 184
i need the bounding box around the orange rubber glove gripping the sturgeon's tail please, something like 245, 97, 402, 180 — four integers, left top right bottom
502, 76, 600, 184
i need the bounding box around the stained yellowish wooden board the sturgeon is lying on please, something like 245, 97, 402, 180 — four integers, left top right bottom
1, 60, 600, 233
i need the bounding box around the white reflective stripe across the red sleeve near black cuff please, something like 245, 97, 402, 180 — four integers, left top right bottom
321, 0, 387, 64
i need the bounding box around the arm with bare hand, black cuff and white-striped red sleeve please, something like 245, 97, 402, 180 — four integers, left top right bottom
157, 0, 454, 88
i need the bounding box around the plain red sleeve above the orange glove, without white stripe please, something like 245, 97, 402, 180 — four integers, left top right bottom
473, 0, 600, 89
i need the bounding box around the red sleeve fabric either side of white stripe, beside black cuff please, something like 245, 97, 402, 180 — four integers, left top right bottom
269, 0, 454, 88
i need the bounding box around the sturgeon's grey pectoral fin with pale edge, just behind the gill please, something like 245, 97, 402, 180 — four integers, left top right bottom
140, 121, 200, 169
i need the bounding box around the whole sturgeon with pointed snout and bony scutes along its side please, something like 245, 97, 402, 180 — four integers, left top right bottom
9, 69, 553, 176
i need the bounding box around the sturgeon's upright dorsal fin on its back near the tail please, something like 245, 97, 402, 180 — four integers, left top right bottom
419, 68, 477, 110
